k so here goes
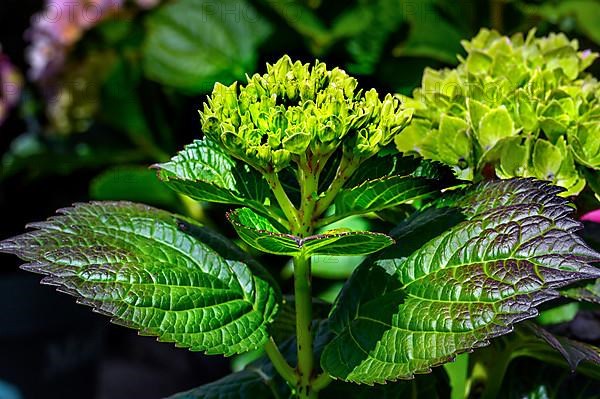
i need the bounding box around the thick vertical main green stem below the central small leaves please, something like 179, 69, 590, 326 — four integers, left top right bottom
294, 255, 317, 399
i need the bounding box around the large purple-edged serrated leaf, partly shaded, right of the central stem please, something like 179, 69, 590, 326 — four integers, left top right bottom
321, 179, 600, 384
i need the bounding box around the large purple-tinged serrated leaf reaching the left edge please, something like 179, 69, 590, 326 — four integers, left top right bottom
0, 202, 280, 355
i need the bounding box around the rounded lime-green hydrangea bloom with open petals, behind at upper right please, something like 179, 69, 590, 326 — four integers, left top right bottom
395, 29, 600, 194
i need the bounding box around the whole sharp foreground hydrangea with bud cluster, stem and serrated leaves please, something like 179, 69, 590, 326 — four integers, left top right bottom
0, 57, 600, 399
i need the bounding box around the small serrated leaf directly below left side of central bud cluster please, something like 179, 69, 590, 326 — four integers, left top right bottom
153, 139, 275, 217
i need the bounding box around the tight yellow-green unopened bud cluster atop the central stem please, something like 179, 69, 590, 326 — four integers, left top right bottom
201, 56, 412, 171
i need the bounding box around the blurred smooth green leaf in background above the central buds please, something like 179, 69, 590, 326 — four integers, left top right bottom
143, 0, 271, 93
